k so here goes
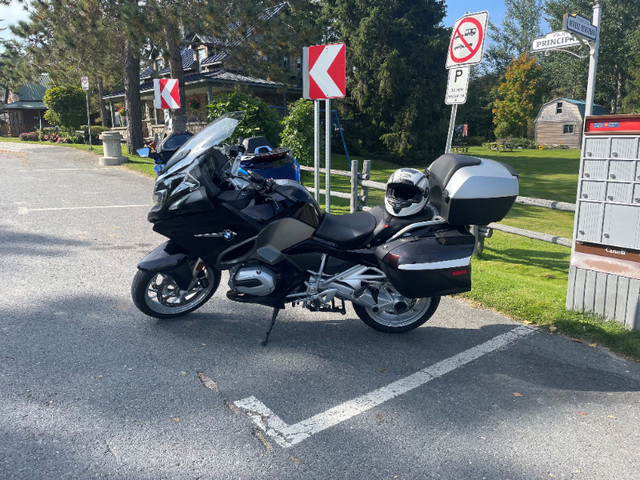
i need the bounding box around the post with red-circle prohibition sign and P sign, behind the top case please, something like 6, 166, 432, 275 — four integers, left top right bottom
444, 12, 489, 153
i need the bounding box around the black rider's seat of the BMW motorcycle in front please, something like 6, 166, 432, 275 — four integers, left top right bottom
316, 212, 377, 249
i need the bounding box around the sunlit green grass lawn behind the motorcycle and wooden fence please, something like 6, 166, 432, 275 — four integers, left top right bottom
0, 137, 640, 360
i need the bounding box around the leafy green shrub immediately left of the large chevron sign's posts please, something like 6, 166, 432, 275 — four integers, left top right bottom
280, 98, 313, 165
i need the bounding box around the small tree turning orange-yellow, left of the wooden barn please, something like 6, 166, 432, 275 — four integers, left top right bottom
493, 53, 544, 138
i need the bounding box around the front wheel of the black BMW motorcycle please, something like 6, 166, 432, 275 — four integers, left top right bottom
131, 266, 220, 319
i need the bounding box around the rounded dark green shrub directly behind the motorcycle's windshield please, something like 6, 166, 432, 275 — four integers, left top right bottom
207, 92, 282, 146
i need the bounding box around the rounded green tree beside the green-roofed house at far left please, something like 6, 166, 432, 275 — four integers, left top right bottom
42, 87, 87, 130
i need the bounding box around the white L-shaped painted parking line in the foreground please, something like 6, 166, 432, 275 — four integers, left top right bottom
234, 326, 535, 448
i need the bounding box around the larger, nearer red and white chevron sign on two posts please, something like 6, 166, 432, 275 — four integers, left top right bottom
302, 43, 346, 100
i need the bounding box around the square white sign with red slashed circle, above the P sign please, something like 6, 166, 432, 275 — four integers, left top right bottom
445, 12, 489, 69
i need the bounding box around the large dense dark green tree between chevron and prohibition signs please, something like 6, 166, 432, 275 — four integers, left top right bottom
326, 0, 449, 163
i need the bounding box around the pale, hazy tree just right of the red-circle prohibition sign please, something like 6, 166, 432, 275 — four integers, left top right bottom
487, 0, 542, 73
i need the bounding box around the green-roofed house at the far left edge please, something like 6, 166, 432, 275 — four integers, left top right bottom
0, 74, 51, 137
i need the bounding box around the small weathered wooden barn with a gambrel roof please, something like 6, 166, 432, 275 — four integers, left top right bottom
535, 97, 607, 148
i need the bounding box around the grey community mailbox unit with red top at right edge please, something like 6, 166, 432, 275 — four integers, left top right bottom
567, 115, 640, 330
